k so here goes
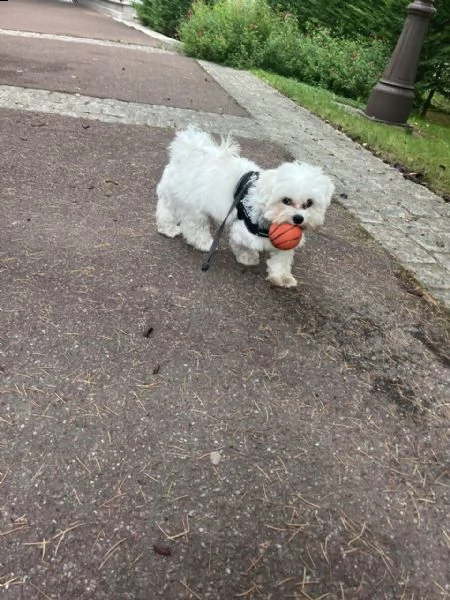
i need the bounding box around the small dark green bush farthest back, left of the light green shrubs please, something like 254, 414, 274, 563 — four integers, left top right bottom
133, 0, 191, 37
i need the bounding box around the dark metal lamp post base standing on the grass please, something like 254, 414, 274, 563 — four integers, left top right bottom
365, 0, 436, 125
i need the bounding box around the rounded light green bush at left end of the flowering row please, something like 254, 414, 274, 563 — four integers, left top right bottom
180, 0, 279, 68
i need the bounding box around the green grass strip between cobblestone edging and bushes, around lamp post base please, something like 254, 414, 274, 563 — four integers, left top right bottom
254, 70, 450, 197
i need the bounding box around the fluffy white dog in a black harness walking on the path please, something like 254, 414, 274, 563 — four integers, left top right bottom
156, 129, 334, 288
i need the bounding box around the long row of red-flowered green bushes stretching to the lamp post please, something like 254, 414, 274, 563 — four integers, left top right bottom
180, 0, 388, 99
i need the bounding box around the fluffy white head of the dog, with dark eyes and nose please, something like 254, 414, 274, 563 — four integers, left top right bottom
260, 162, 334, 229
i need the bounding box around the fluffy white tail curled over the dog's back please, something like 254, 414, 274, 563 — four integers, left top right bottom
169, 127, 240, 163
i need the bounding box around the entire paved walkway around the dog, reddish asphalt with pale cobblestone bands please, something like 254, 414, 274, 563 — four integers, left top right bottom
0, 0, 450, 600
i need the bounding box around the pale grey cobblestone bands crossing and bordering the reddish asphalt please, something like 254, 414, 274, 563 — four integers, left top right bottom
0, 22, 450, 307
